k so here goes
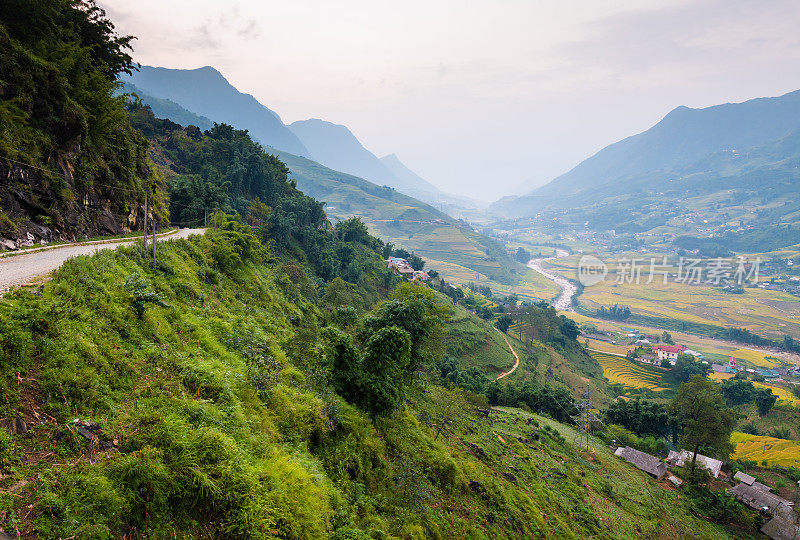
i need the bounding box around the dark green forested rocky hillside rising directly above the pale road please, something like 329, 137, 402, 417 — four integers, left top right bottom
0, 0, 167, 248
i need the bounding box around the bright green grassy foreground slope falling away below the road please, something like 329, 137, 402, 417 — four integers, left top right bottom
0, 234, 740, 538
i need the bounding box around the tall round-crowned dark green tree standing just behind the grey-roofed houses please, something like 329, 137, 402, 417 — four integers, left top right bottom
669, 375, 736, 477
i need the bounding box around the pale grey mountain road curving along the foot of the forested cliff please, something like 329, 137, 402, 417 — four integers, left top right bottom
0, 229, 205, 295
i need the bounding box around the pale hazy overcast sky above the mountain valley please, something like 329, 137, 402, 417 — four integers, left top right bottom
98, 0, 800, 201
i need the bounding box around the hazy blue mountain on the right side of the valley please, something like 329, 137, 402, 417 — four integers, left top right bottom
490, 91, 800, 224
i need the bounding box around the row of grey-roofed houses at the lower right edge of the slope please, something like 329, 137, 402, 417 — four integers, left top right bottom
614, 446, 800, 540
